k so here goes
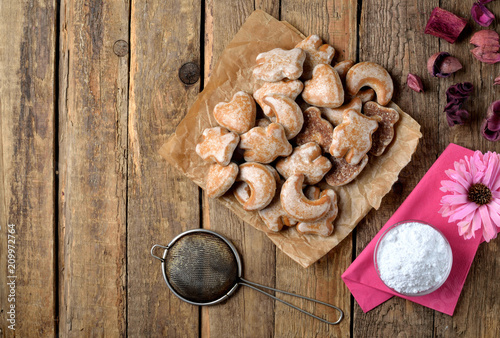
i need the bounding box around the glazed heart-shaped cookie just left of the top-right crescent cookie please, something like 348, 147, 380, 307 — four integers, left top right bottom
302, 64, 344, 108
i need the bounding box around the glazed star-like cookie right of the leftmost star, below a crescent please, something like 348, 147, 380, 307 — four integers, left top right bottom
239, 123, 292, 163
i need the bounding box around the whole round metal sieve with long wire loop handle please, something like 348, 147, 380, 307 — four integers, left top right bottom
151, 229, 344, 325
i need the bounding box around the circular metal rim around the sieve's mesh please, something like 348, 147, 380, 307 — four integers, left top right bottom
161, 229, 243, 306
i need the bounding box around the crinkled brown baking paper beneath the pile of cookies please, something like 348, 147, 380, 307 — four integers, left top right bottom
160, 11, 422, 267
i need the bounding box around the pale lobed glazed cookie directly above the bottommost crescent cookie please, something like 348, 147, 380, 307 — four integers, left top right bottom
276, 142, 332, 185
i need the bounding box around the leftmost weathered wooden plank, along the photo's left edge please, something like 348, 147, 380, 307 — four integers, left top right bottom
0, 0, 57, 337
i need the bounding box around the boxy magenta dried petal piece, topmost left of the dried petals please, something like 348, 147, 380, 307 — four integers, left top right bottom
425, 7, 467, 43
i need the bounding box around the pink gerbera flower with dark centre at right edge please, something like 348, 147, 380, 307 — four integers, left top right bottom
439, 151, 500, 242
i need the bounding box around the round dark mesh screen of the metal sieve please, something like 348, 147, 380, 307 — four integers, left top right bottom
165, 232, 238, 303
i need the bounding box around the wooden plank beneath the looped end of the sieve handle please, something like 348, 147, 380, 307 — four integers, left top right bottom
274, 0, 357, 337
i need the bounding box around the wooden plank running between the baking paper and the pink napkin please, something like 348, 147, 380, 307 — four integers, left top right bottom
353, 0, 439, 337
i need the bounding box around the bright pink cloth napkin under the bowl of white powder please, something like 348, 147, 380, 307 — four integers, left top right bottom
342, 144, 482, 316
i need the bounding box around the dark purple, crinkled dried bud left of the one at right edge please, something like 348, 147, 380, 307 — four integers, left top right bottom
444, 82, 474, 127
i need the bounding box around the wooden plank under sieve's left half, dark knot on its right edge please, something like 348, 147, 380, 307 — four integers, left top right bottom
127, 0, 201, 337
